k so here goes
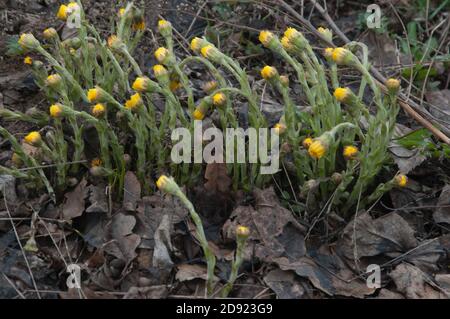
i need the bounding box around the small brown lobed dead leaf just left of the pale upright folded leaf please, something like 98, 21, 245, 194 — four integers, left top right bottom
104, 213, 141, 262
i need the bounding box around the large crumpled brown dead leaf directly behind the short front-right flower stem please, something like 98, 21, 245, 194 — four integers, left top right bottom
223, 188, 306, 262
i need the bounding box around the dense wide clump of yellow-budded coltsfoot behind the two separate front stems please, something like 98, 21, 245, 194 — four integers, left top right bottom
0, 1, 407, 218
